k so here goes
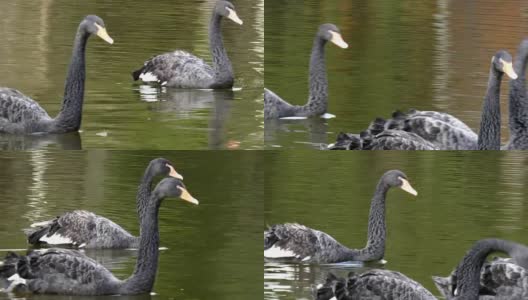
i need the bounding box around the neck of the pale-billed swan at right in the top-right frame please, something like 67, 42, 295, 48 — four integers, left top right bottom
478, 64, 503, 150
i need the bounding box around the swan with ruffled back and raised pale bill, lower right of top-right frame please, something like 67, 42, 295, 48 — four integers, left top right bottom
327, 51, 517, 150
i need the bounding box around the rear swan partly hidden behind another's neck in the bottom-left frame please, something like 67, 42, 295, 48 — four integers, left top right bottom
25, 158, 183, 249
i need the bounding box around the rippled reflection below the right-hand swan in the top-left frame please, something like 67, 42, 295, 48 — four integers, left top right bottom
139, 85, 239, 149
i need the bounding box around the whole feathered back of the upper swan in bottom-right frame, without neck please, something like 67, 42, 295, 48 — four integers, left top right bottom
264, 223, 346, 263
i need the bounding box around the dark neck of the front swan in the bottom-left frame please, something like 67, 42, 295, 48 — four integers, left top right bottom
121, 196, 161, 294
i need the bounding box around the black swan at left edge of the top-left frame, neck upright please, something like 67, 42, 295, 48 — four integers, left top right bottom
0, 16, 114, 134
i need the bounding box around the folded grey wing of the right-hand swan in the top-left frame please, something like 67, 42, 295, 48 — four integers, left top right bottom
139, 51, 215, 88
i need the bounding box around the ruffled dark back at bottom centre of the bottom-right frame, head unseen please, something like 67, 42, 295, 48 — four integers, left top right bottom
316, 269, 436, 300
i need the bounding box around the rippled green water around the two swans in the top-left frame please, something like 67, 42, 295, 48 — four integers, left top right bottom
0, 0, 264, 149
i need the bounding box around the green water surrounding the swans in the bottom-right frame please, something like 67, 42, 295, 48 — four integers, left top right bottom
264, 151, 528, 299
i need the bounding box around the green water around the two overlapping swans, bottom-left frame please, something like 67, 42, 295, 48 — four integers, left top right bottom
0, 150, 263, 299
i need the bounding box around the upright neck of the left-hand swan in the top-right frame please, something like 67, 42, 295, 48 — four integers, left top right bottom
304, 37, 328, 115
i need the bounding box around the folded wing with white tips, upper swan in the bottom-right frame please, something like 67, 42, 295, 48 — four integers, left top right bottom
264, 224, 319, 260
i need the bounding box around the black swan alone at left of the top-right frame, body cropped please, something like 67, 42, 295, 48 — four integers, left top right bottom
264, 24, 348, 119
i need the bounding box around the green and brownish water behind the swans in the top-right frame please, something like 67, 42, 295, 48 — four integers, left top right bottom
265, 0, 528, 149
